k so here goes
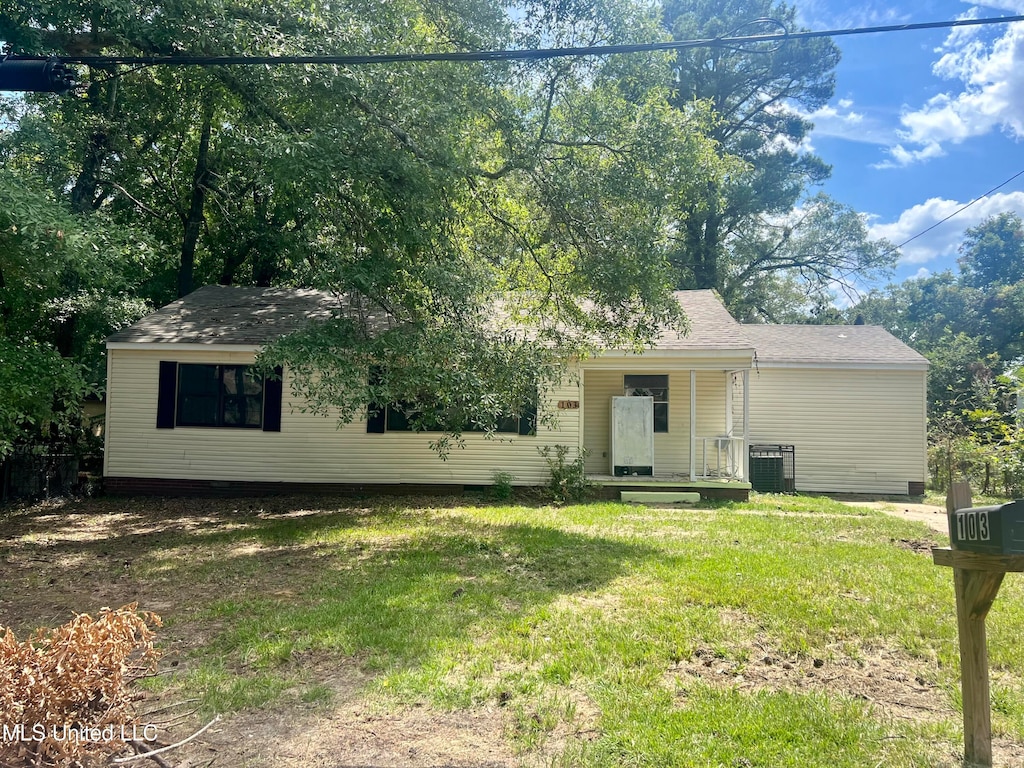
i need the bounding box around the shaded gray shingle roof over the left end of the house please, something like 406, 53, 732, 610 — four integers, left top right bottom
106, 286, 338, 346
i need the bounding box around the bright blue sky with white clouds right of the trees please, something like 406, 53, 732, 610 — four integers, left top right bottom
795, 0, 1024, 280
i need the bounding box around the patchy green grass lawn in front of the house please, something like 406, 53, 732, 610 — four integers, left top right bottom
8, 496, 1024, 768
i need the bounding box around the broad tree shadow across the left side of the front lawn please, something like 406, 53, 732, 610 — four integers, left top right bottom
0, 499, 657, 684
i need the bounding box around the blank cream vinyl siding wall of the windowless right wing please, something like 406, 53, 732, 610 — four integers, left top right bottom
751, 365, 928, 494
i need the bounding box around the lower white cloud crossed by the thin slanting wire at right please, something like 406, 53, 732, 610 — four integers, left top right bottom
868, 191, 1024, 264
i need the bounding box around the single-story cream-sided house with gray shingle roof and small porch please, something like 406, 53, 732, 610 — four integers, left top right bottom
103, 286, 928, 498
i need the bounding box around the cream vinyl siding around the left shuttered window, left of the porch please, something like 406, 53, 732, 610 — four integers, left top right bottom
104, 345, 580, 484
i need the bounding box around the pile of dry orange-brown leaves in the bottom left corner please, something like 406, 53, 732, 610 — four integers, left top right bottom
0, 603, 161, 768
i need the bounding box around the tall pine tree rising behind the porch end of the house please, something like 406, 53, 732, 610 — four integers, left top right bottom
663, 0, 895, 321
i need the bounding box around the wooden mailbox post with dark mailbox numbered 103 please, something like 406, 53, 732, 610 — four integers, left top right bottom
932, 494, 1024, 766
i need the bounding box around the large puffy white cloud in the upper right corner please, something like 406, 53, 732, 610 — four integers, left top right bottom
880, 16, 1024, 167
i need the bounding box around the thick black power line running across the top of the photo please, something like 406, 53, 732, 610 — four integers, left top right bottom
44, 15, 1024, 67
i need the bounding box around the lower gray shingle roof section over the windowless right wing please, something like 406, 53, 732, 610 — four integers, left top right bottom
743, 325, 928, 366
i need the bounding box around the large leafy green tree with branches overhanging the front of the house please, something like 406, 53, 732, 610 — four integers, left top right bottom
0, 0, 722, 444
